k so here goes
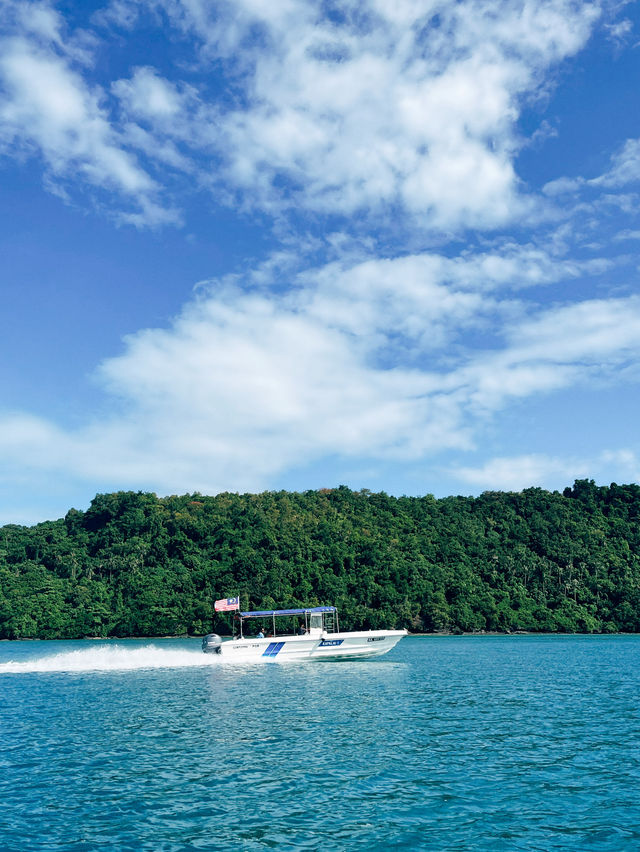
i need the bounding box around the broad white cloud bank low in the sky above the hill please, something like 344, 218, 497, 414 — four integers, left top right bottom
0, 246, 640, 500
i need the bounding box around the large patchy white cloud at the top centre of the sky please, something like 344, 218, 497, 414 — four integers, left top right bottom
99, 0, 597, 230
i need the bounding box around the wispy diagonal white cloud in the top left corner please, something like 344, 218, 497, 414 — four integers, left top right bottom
0, 4, 177, 224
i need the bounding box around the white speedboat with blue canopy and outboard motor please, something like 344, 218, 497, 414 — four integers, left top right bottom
202, 606, 407, 663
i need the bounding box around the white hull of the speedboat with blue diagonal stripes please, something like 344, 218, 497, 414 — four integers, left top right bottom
210, 630, 407, 663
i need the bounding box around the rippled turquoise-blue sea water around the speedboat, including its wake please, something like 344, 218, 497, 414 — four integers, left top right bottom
0, 636, 640, 852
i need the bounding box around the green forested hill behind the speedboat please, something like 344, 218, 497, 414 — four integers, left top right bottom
0, 480, 640, 639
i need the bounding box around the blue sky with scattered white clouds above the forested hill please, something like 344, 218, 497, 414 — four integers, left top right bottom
0, 0, 640, 524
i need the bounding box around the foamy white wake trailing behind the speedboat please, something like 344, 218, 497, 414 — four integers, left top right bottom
0, 645, 220, 675
